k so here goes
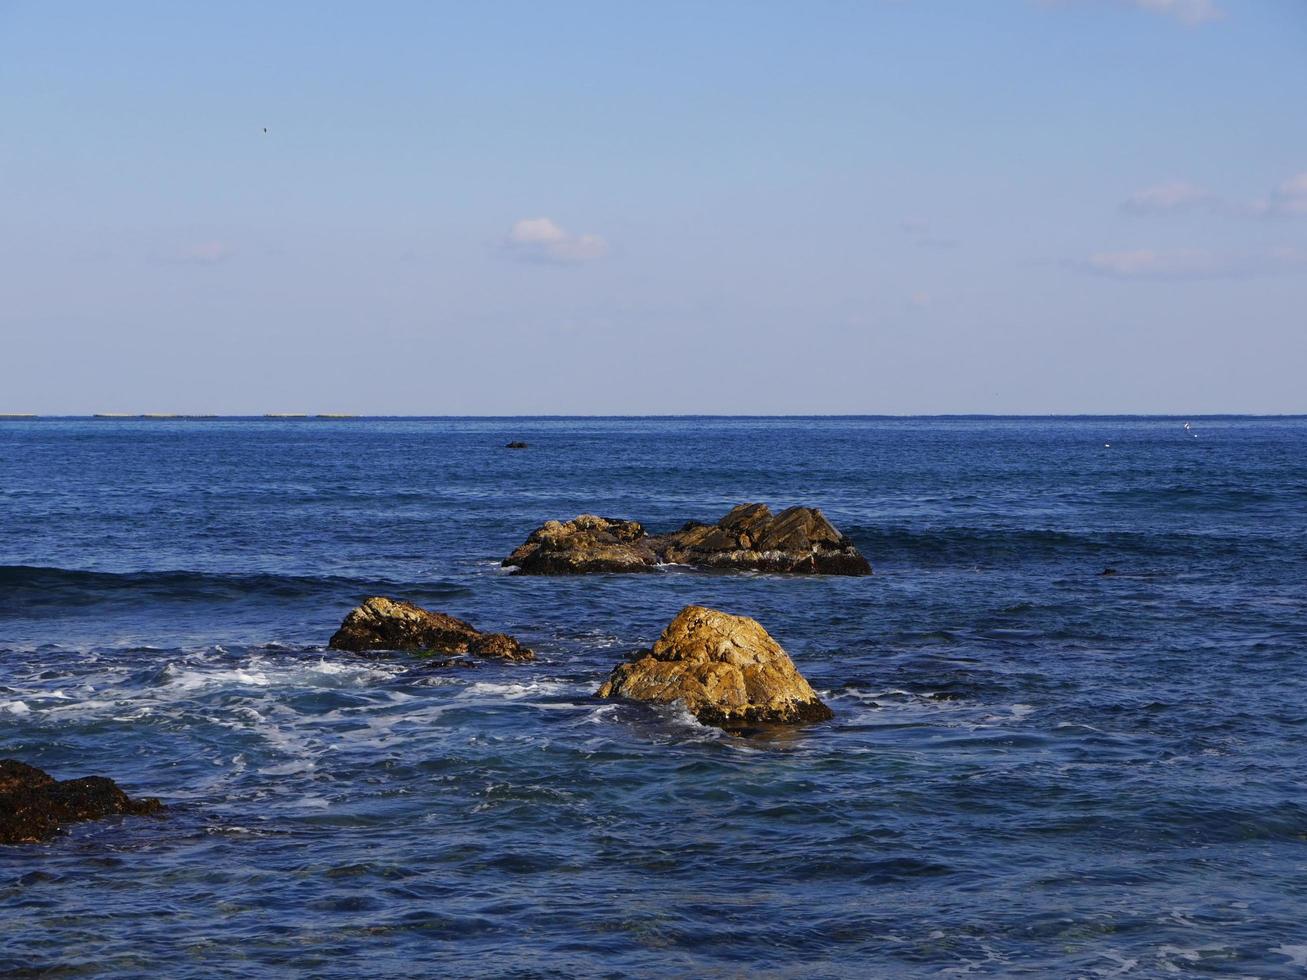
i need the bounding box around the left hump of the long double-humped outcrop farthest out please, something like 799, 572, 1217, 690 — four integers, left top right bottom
503, 514, 660, 575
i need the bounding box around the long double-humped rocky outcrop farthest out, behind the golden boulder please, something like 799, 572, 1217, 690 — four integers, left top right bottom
503, 503, 872, 575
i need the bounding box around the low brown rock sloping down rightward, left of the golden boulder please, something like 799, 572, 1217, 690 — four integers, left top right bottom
328, 596, 536, 660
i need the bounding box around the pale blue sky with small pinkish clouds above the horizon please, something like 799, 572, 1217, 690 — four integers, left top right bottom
0, 0, 1307, 414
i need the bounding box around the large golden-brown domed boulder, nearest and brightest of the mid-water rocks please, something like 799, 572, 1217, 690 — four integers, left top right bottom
599, 606, 834, 729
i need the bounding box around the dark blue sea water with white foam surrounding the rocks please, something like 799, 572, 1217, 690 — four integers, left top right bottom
0, 418, 1307, 977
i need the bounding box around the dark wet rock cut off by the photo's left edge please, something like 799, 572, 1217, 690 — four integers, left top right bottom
0, 759, 165, 844
